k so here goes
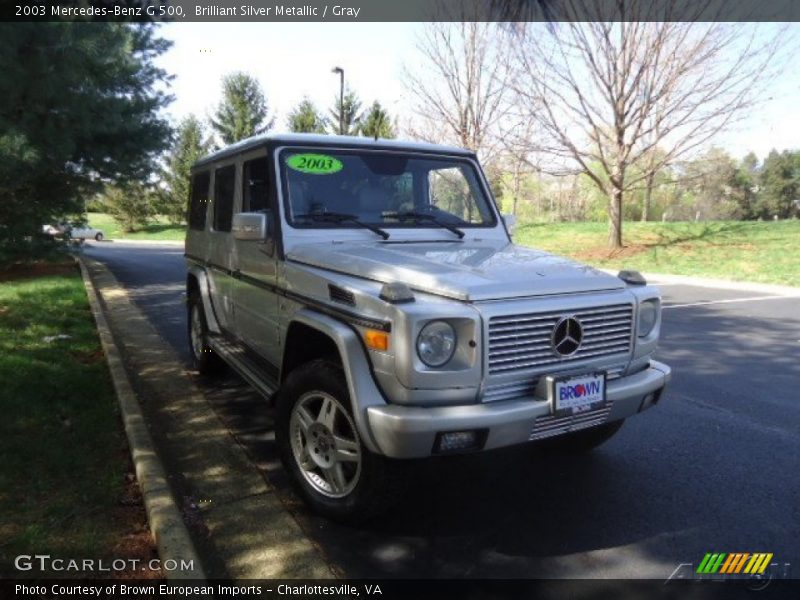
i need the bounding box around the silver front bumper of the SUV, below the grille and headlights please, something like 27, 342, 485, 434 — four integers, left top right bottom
367, 360, 672, 458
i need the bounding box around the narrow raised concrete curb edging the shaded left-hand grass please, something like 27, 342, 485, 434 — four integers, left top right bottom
76, 258, 206, 581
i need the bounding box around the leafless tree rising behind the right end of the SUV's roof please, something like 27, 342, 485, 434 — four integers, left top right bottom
405, 19, 510, 160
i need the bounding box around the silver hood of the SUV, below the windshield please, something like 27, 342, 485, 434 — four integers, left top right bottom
287, 241, 625, 301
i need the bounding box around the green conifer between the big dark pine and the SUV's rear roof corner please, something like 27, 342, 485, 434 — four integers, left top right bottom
160, 115, 210, 224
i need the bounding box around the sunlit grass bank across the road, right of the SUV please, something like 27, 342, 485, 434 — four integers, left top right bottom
514, 220, 800, 286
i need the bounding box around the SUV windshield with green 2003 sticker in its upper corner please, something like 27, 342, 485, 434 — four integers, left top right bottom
279, 149, 496, 230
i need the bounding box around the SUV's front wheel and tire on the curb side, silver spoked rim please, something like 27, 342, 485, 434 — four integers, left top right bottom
275, 360, 403, 522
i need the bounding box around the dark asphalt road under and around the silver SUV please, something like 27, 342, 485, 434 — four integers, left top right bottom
85, 242, 800, 578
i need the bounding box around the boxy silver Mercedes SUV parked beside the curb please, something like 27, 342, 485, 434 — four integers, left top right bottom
186, 134, 670, 519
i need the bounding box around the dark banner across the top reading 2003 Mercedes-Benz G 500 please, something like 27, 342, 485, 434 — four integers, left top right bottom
0, 0, 800, 23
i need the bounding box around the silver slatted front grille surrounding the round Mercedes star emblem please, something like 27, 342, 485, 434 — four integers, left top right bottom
489, 304, 633, 374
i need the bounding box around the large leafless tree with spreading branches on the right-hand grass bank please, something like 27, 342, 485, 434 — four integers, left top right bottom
513, 18, 778, 247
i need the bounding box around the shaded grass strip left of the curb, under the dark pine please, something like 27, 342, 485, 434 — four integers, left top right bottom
0, 260, 158, 577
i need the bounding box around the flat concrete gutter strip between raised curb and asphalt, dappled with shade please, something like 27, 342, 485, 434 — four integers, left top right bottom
81, 257, 336, 581
